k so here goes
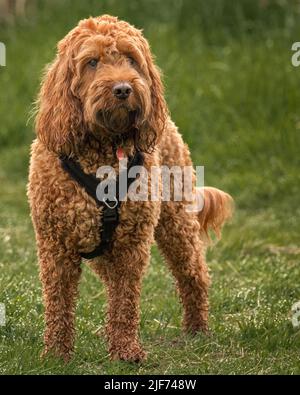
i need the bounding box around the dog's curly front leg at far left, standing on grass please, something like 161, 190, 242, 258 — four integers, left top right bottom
39, 243, 81, 361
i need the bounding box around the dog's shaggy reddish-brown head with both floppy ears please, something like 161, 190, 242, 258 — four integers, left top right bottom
36, 15, 167, 153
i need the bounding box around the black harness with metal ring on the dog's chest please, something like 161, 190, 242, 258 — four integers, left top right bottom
60, 151, 144, 259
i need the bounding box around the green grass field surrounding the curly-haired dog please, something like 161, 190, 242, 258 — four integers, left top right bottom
0, 0, 300, 374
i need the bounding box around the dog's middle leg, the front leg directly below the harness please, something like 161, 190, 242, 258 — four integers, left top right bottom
105, 244, 150, 362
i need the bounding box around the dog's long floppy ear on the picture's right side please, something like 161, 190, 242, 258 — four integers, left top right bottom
140, 40, 168, 151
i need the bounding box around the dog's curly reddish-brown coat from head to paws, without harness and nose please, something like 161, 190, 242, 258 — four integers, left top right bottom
28, 15, 231, 361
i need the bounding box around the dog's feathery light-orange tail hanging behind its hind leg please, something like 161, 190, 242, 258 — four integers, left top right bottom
196, 187, 233, 241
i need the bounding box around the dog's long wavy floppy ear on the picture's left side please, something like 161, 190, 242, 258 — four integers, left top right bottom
36, 39, 83, 154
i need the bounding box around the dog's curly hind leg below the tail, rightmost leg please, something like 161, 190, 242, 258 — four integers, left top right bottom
155, 202, 209, 333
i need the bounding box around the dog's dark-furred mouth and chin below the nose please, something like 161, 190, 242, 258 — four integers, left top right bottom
96, 105, 140, 135
